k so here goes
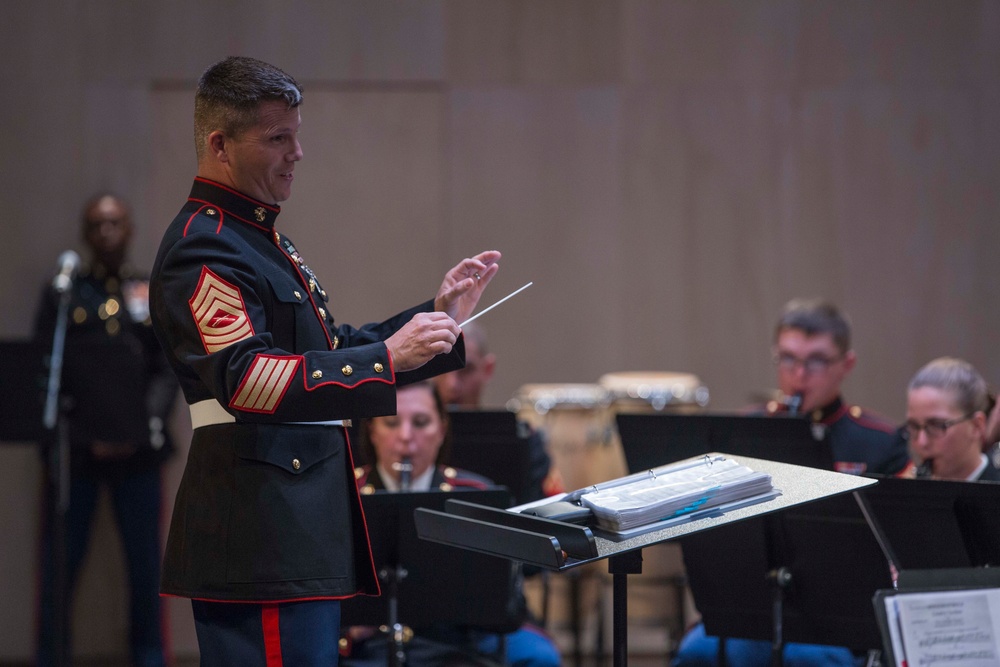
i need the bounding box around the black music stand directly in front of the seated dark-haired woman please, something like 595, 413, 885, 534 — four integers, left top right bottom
341, 488, 524, 664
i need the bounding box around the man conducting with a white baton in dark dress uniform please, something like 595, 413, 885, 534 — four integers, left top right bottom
150, 57, 500, 667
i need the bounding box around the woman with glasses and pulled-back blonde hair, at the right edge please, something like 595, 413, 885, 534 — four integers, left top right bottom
902, 357, 1000, 482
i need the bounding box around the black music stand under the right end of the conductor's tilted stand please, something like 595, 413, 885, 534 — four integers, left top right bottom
680, 495, 892, 663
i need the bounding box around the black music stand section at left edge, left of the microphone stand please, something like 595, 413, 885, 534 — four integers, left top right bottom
0, 340, 45, 443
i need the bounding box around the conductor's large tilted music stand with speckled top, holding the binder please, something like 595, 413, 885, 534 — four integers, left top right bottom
416, 453, 875, 667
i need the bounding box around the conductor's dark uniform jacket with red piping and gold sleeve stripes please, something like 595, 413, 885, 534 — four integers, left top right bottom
150, 179, 464, 602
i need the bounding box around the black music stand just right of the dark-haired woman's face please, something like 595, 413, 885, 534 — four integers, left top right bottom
448, 410, 534, 504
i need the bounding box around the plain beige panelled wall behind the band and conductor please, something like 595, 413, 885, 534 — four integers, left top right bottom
0, 0, 1000, 662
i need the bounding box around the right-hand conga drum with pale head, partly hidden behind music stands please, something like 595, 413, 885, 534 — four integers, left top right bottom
598, 371, 709, 656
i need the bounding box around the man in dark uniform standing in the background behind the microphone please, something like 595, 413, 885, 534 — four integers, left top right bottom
35, 193, 177, 667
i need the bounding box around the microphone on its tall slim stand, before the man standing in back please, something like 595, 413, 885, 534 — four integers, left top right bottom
42, 281, 72, 667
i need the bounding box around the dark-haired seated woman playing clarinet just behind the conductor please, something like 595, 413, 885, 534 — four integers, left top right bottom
342, 381, 560, 667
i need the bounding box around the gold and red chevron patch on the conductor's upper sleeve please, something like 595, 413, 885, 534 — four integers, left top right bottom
188, 266, 254, 354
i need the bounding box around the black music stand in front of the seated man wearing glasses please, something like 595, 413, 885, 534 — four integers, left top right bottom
615, 412, 833, 472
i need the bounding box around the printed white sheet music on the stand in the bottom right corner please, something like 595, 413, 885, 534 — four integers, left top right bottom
884, 588, 1000, 667
